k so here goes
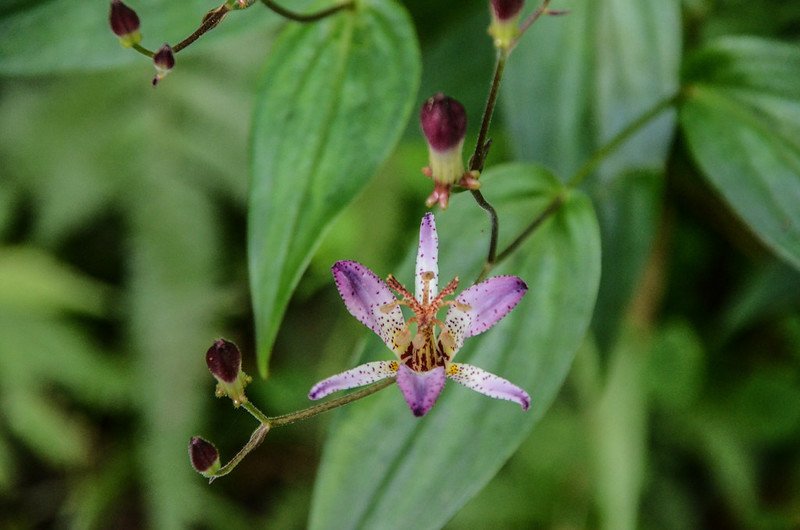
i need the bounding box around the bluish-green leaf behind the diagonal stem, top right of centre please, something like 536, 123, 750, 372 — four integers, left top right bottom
501, 0, 682, 350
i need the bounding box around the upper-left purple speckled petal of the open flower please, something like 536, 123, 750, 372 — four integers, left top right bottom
331, 261, 405, 352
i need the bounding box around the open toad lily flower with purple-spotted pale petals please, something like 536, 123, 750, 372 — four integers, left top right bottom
308, 213, 531, 416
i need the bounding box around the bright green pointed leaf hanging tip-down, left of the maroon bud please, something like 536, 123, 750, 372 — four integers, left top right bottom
248, 0, 420, 376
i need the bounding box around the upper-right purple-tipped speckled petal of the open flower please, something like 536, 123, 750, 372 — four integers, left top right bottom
445, 276, 528, 351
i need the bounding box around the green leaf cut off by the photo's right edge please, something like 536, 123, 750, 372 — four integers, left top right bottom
680, 38, 800, 268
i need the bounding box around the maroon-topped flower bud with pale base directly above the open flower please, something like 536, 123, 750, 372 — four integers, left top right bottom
419, 93, 478, 208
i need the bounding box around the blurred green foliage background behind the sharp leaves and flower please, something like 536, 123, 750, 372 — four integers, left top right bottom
0, 0, 800, 529
